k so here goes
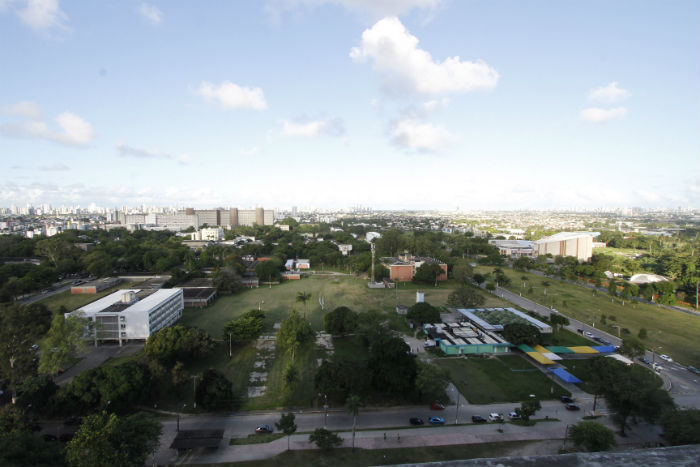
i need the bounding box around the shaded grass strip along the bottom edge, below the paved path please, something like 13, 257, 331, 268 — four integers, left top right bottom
205, 441, 532, 467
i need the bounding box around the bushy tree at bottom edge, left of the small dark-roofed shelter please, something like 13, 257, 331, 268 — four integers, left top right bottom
66, 412, 162, 467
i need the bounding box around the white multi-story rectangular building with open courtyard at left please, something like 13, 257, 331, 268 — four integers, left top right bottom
65, 289, 185, 345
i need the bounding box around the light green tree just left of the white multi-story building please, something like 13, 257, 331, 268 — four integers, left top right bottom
39, 314, 91, 375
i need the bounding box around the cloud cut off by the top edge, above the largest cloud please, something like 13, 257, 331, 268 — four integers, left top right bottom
266, 0, 443, 19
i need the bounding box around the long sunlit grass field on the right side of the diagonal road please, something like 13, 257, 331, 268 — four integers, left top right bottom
477, 266, 700, 366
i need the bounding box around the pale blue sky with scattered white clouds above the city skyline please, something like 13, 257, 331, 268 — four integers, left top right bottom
0, 0, 700, 210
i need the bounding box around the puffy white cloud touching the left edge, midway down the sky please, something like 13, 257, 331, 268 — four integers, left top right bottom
0, 102, 95, 146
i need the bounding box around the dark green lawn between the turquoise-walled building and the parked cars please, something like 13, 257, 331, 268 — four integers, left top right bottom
434, 355, 570, 404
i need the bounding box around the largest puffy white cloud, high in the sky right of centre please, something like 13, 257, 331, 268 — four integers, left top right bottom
350, 17, 499, 94
